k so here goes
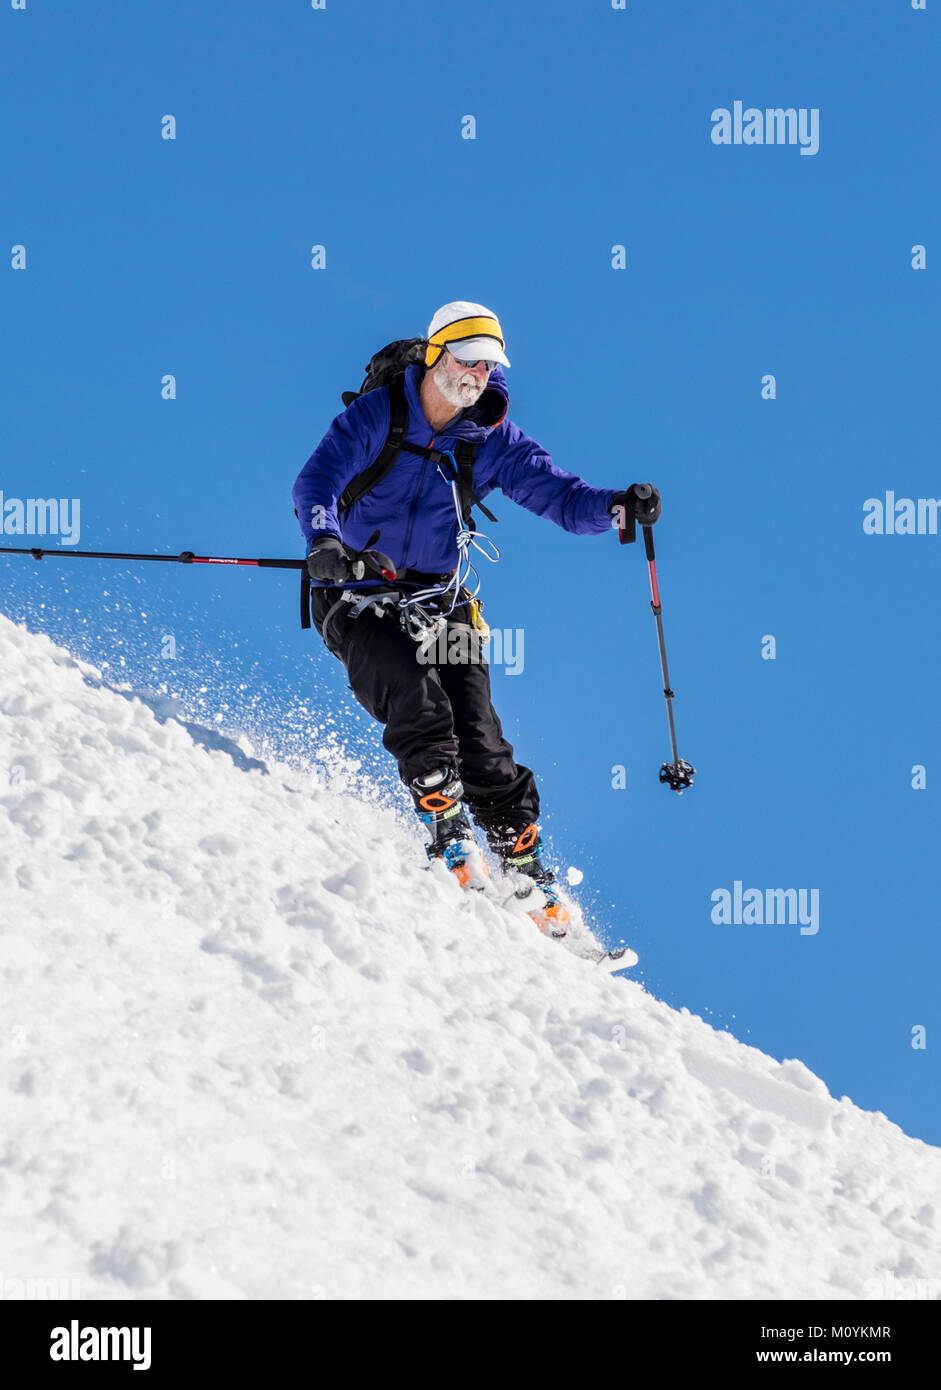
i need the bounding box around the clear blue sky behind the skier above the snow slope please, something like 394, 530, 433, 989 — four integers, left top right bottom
0, 0, 941, 1143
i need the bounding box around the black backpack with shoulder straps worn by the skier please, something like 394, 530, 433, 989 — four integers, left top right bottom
300, 338, 496, 628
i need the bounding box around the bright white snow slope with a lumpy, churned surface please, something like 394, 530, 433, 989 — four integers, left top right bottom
0, 617, 941, 1298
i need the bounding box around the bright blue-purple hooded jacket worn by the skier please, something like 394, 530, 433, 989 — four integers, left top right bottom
293, 363, 614, 574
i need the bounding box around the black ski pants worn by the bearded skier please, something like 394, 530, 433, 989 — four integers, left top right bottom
311, 589, 539, 840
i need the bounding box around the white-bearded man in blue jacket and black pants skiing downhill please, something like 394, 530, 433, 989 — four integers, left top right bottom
293, 300, 660, 935
